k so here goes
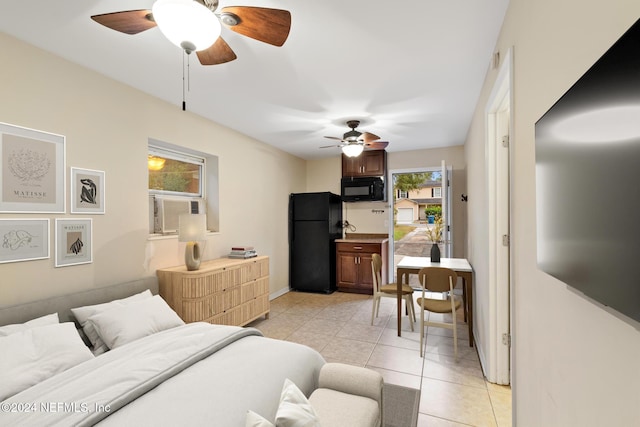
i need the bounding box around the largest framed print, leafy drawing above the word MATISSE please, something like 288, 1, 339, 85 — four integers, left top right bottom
0, 123, 65, 213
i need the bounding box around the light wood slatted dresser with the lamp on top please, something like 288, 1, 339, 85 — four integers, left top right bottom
156, 256, 269, 326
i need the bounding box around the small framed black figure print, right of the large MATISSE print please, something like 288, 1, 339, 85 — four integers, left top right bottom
71, 168, 105, 214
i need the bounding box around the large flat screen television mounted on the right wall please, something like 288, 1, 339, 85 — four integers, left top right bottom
535, 20, 640, 322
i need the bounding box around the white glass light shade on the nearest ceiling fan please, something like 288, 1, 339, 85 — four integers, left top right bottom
152, 0, 220, 53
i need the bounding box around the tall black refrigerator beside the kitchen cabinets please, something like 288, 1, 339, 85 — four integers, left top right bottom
289, 192, 342, 293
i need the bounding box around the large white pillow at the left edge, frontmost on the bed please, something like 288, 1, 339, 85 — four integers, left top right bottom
0, 322, 93, 401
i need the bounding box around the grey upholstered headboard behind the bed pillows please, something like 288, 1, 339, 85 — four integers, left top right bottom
0, 277, 158, 326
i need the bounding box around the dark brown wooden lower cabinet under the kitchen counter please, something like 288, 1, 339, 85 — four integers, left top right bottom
336, 242, 387, 295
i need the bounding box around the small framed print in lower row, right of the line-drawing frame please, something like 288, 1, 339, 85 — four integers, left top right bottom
55, 218, 93, 267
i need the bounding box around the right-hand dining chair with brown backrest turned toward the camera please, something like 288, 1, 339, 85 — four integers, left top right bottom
416, 267, 462, 361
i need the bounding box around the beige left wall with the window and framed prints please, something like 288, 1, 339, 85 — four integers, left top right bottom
0, 34, 306, 306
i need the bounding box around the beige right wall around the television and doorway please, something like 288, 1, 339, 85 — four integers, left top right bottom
465, 0, 640, 427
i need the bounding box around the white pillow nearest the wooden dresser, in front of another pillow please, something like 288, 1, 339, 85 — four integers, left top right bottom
88, 295, 184, 348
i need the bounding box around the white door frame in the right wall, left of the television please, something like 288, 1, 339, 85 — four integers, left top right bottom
484, 48, 514, 385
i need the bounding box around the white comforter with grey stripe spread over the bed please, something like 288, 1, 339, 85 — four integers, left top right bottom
0, 323, 324, 427
